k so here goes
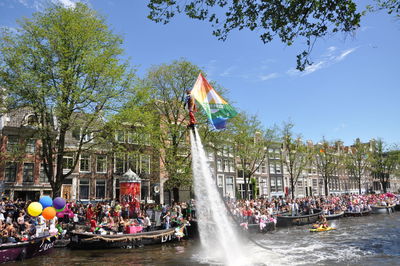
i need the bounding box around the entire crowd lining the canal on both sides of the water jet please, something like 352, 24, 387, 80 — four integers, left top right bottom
0, 193, 400, 243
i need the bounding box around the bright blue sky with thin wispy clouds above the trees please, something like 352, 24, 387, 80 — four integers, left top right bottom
0, 0, 400, 144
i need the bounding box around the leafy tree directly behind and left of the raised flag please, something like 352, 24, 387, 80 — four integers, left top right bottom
132, 60, 205, 201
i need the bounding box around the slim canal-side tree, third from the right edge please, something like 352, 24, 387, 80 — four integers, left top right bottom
313, 139, 342, 196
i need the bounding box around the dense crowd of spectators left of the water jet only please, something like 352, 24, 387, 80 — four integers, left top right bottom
0, 200, 195, 244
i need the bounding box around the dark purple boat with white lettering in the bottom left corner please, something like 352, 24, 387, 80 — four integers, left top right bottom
0, 235, 56, 263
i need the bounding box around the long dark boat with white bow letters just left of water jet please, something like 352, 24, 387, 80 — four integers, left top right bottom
69, 225, 186, 249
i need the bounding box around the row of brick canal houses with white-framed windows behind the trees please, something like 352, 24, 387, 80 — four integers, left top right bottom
0, 110, 400, 203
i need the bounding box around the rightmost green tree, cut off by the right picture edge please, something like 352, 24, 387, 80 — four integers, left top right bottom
369, 139, 400, 193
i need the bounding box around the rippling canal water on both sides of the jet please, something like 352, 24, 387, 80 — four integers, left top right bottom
9, 212, 400, 266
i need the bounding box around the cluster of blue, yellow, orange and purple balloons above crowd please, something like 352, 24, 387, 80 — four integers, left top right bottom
28, 196, 66, 220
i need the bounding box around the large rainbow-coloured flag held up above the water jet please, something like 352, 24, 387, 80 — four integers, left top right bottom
190, 73, 237, 129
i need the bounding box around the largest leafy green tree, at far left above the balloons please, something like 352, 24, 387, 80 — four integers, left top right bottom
0, 3, 132, 196
